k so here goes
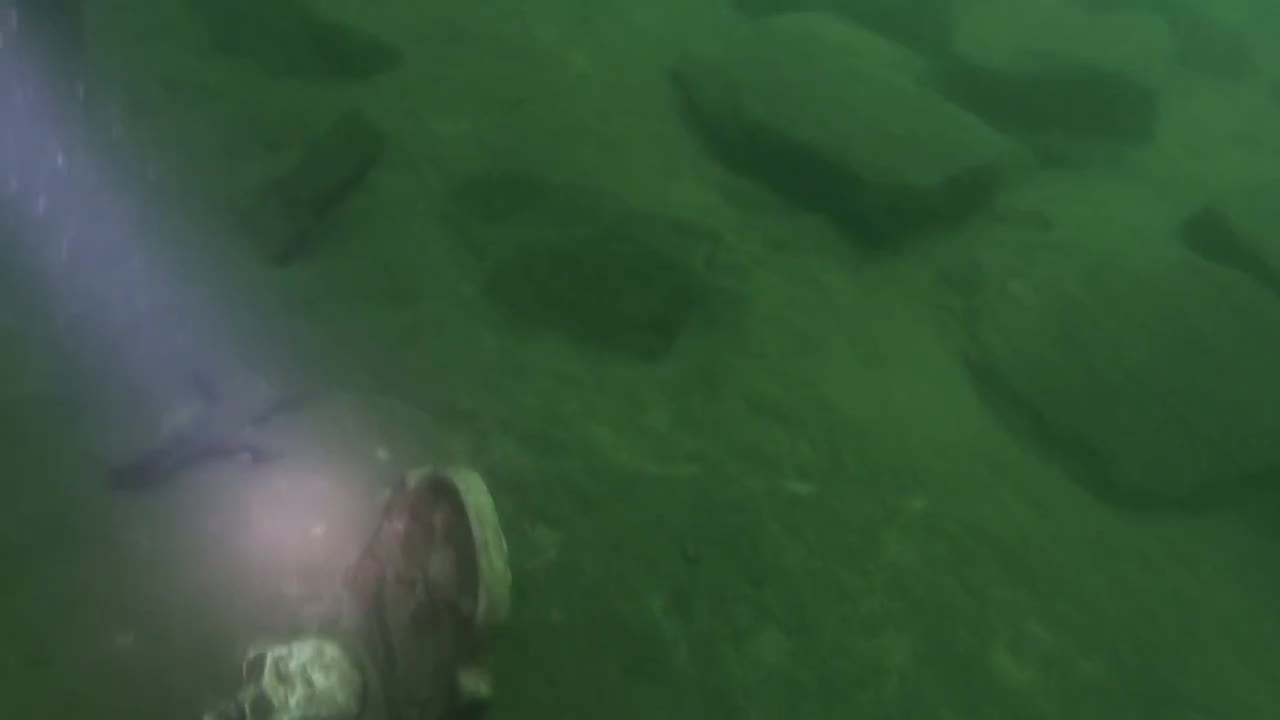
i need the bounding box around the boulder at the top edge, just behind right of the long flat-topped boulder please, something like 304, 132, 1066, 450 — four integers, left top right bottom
934, 0, 1172, 155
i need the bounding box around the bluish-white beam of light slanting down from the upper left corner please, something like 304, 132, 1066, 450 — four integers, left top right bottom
0, 0, 261, 417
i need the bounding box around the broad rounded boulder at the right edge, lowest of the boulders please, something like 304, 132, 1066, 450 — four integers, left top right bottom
950, 184, 1280, 510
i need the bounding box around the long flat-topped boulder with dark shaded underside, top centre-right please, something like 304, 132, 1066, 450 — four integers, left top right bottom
675, 13, 1020, 250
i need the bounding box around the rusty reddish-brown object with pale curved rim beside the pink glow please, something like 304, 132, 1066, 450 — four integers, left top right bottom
347, 468, 511, 720
